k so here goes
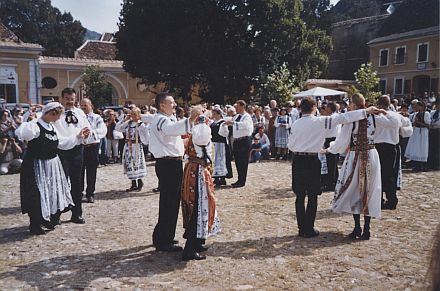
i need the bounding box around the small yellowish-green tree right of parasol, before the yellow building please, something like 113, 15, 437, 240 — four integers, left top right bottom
354, 63, 381, 104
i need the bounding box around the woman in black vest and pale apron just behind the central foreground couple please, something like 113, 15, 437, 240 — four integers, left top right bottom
211, 108, 232, 185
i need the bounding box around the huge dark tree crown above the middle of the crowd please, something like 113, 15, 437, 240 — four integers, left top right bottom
116, 0, 331, 102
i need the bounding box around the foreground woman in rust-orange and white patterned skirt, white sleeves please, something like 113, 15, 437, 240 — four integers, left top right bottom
181, 108, 220, 261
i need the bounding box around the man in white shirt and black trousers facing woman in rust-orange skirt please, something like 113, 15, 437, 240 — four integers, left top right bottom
149, 93, 198, 253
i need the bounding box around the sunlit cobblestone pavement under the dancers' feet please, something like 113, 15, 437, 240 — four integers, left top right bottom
0, 161, 440, 290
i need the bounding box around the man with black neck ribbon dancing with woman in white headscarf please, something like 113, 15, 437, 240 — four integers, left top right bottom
51, 88, 90, 225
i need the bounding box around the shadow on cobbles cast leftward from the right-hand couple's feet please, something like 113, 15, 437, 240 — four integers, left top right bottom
207, 232, 355, 259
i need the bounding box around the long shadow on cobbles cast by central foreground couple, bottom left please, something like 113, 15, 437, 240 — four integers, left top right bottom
0, 246, 186, 290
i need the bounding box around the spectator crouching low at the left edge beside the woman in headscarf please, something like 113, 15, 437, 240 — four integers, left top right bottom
0, 137, 22, 175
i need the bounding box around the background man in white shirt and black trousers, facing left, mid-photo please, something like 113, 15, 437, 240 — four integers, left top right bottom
222, 100, 254, 188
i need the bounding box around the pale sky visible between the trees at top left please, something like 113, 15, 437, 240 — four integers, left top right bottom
52, 0, 339, 33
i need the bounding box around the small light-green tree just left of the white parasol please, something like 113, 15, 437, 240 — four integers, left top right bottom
259, 63, 298, 104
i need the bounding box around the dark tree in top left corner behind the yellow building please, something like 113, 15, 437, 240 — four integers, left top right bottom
0, 0, 86, 57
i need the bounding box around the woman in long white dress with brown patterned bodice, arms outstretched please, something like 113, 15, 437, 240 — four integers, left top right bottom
323, 94, 399, 240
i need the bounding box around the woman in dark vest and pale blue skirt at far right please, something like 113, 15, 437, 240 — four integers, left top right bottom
405, 101, 431, 171
